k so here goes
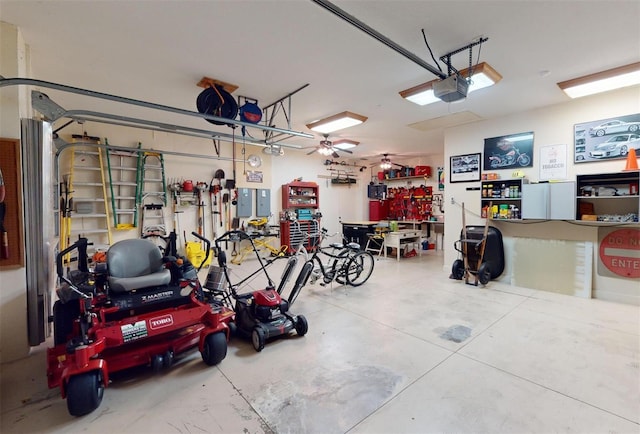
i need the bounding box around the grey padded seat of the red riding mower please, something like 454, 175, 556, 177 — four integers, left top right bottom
107, 239, 171, 294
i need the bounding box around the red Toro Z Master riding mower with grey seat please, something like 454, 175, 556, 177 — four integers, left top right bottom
47, 233, 234, 416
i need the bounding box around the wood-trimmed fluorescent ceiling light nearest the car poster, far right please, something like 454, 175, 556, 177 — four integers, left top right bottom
558, 62, 640, 98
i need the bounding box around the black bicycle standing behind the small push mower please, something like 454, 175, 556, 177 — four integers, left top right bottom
298, 228, 375, 286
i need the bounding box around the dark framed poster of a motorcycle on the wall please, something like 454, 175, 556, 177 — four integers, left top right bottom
484, 131, 533, 170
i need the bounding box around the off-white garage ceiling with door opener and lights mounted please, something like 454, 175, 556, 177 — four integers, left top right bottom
0, 0, 640, 161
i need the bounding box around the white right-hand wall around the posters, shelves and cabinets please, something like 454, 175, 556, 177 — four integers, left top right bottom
444, 86, 640, 304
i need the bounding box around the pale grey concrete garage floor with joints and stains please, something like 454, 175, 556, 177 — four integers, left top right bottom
0, 251, 640, 433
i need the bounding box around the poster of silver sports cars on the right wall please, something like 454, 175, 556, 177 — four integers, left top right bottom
573, 113, 640, 163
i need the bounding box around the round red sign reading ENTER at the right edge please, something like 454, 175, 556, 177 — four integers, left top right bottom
600, 229, 640, 278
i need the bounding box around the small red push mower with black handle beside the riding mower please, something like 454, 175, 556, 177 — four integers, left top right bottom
210, 231, 313, 351
